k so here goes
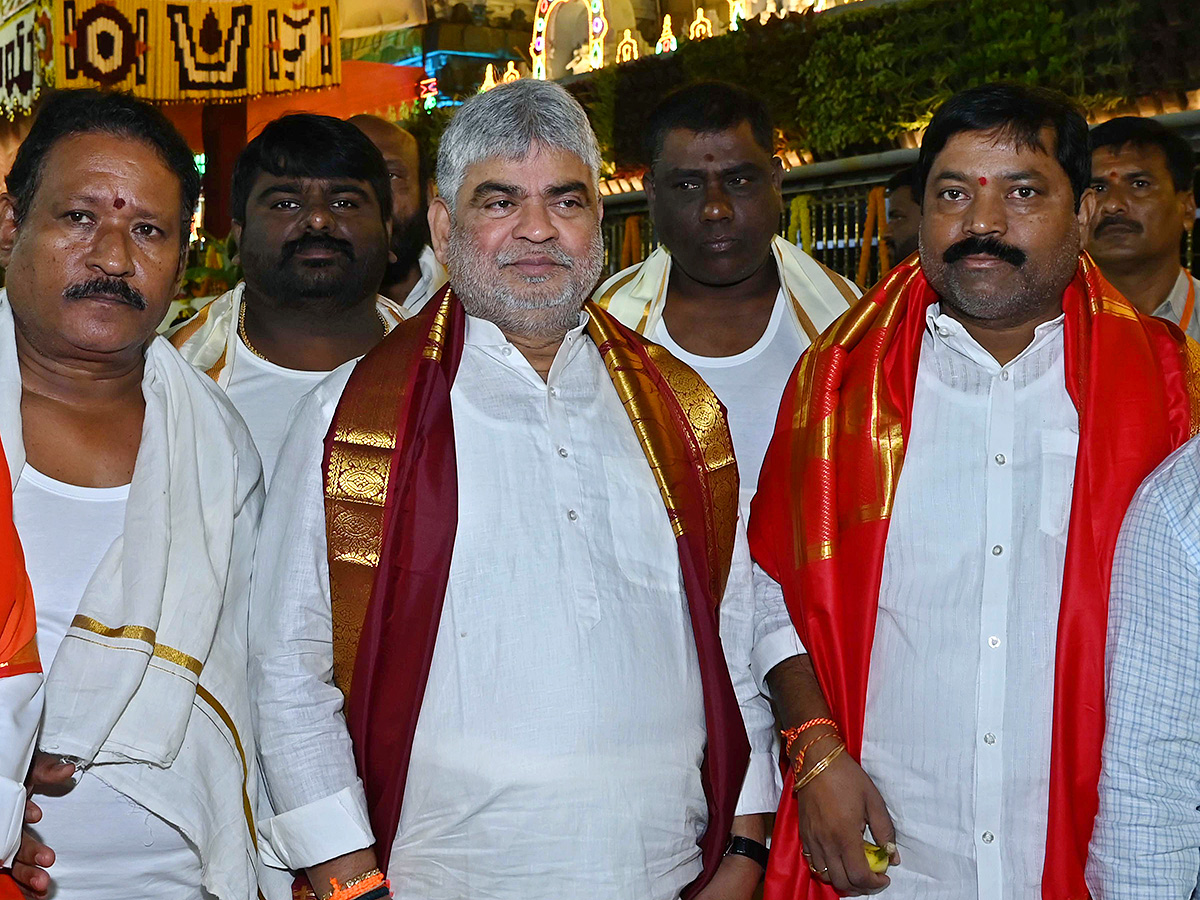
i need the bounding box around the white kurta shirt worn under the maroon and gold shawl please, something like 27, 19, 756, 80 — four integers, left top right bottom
251, 318, 791, 900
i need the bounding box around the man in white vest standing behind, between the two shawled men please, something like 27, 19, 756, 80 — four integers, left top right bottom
594, 82, 858, 518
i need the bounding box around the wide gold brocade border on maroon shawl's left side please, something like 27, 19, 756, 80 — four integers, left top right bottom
325, 292, 451, 700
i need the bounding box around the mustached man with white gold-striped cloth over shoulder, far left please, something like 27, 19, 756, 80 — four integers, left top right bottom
0, 91, 272, 900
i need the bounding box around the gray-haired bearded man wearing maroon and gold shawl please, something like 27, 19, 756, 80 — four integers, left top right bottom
250, 80, 786, 900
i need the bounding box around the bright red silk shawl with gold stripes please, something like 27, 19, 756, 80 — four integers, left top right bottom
750, 254, 1200, 900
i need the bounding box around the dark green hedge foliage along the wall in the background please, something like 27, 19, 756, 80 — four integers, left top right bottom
388, 0, 1200, 173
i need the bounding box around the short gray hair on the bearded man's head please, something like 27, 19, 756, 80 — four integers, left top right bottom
438, 78, 600, 215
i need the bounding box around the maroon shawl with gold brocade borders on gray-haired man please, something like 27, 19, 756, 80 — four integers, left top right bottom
325, 289, 749, 898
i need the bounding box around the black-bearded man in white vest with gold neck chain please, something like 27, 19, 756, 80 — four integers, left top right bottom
170, 114, 406, 484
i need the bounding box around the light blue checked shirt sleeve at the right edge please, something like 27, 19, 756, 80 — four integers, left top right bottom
1087, 440, 1200, 900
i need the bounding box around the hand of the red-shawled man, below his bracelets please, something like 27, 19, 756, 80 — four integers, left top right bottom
796, 752, 900, 896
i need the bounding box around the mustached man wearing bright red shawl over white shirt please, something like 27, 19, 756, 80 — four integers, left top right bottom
750, 85, 1200, 900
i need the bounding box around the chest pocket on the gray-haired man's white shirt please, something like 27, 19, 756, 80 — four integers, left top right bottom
604, 456, 679, 590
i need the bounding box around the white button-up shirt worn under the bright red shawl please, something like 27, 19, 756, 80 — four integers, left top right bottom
863, 305, 1079, 900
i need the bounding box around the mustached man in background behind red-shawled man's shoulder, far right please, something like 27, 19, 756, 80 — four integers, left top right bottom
1086, 115, 1200, 338
